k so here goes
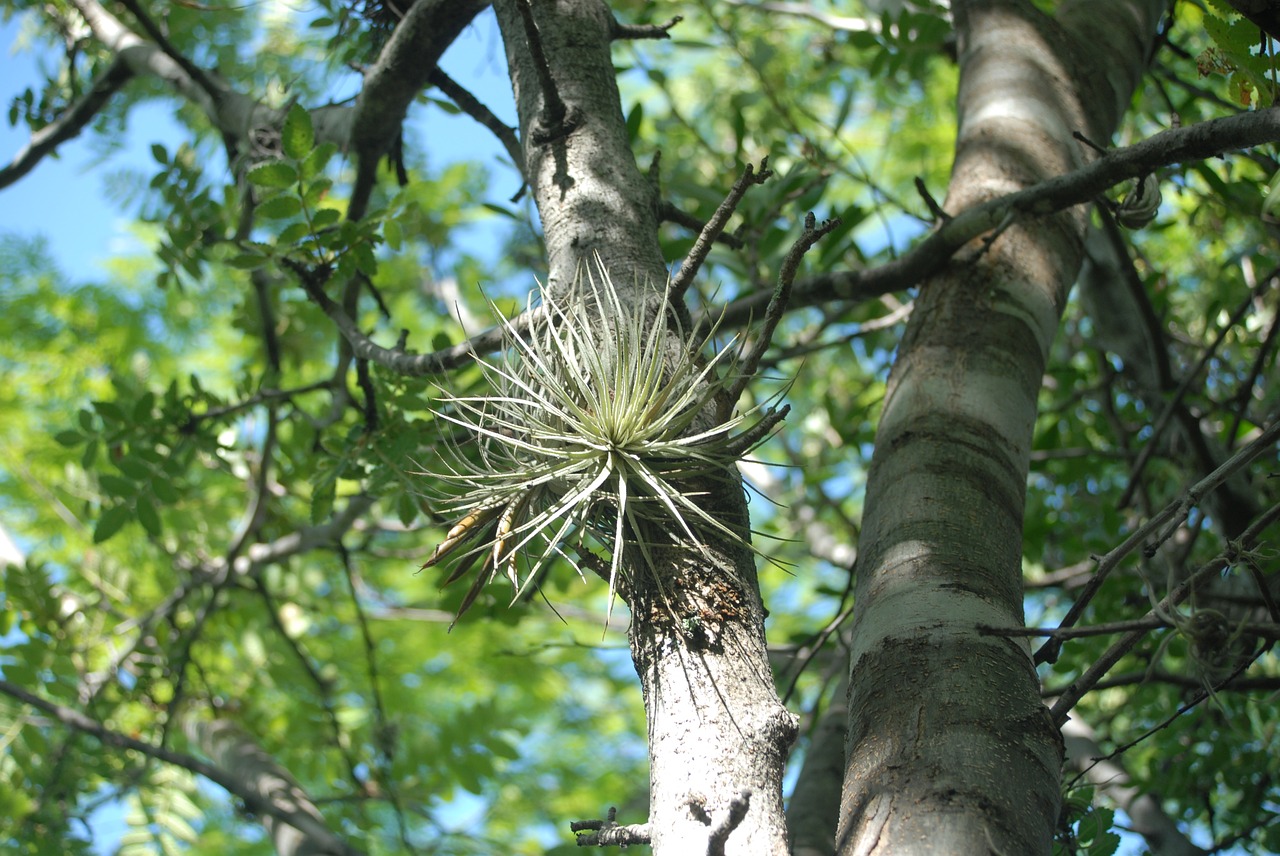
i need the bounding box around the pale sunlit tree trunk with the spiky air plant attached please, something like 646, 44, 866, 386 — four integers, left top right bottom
494, 0, 795, 856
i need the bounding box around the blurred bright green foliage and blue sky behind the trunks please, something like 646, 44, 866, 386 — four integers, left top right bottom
0, 0, 1280, 853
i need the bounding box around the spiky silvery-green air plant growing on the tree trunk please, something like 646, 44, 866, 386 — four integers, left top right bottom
422, 261, 785, 617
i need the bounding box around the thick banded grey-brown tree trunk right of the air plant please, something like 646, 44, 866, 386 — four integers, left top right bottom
837, 1, 1164, 856
